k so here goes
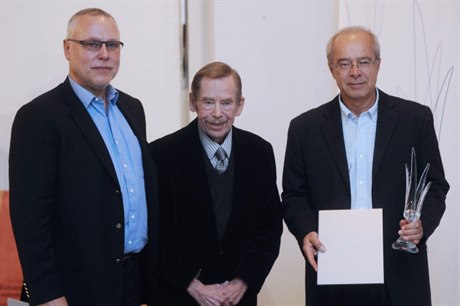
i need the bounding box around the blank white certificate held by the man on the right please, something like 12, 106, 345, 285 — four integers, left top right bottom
317, 209, 383, 285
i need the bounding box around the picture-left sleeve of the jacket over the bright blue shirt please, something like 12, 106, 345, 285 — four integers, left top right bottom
9, 103, 64, 305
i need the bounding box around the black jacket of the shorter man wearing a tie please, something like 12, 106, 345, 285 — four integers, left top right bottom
150, 120, 282, 306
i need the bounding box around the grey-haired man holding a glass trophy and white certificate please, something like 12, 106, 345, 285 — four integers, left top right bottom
282, 27, 449, 306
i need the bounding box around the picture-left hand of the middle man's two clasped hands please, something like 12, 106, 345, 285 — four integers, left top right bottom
187, 278, 225, 306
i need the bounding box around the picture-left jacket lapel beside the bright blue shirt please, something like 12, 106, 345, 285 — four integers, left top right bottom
64, 80, 118, 185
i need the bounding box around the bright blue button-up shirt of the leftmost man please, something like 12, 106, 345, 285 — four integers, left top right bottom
69, 76, 147, 254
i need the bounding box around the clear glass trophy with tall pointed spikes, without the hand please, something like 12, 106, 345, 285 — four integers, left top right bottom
392, 148, 431, 253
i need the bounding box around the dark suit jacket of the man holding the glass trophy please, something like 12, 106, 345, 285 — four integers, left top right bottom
282, 91, 449, 306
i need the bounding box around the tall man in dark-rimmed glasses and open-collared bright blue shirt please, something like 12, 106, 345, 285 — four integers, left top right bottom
10, 8, 158, 306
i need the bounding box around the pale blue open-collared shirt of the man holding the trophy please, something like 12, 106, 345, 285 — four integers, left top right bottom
339, 90, 379, 209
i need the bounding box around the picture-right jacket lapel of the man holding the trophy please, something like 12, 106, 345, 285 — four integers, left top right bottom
372, 90, 398, 179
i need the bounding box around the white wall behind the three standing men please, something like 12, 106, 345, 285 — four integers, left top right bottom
0, 0, 460, 306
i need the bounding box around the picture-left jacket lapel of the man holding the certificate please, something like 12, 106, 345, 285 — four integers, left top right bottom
321, 96, 350, 189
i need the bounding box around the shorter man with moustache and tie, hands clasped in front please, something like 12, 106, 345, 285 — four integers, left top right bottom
150, 62, 282, 306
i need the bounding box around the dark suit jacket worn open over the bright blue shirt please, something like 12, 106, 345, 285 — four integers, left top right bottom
9, 79, 158, 306
